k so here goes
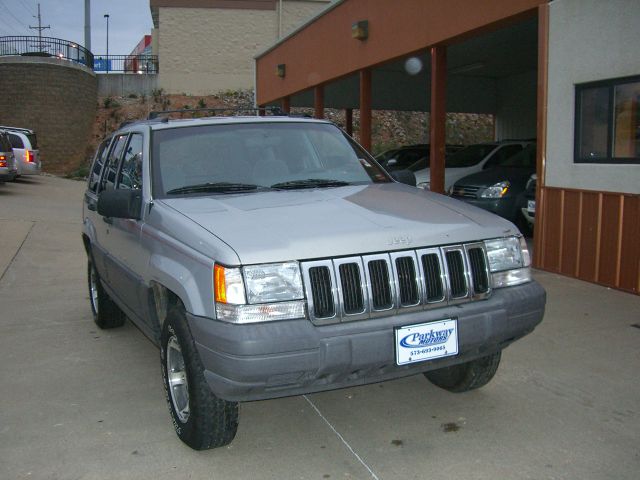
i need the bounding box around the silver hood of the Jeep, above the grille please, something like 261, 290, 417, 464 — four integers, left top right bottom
158, 183, 518, 264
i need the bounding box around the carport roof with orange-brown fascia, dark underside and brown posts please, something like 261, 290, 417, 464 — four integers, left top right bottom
255, 0, 549, 263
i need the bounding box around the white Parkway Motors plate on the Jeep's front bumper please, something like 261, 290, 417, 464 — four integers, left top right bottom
395, 318, 458, 365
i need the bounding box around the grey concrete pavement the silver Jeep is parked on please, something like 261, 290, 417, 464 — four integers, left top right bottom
0, 176, 640, 480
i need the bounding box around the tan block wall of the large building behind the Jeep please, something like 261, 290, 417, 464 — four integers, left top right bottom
156, 0, 329, 95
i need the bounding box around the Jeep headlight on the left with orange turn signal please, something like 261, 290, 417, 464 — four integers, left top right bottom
214, 262, 306, 323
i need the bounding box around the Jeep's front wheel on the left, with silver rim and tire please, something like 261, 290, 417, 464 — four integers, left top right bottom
160, 306, 238, 450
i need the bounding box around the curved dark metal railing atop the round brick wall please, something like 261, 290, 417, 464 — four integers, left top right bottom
0, 36, 93, 68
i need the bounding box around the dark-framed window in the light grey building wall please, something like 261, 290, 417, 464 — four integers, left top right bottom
574, 76, 640, 164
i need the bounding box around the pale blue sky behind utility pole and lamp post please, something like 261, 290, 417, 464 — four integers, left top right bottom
0, 0, 153, 55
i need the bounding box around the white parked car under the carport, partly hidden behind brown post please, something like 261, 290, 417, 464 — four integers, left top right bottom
415, 140, 533, 192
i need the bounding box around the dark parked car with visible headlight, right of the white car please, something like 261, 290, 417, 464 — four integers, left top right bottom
451, 144, 536, 225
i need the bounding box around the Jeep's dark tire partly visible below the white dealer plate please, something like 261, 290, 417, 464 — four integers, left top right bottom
424, 351, 502, 393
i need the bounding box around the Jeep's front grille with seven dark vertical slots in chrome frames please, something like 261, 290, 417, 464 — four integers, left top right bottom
301, 243, 491, 324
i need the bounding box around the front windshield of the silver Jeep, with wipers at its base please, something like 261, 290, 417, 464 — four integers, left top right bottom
152, 122, 391, 196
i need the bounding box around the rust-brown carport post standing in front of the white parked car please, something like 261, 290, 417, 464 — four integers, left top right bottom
429, 45, 447, 193
